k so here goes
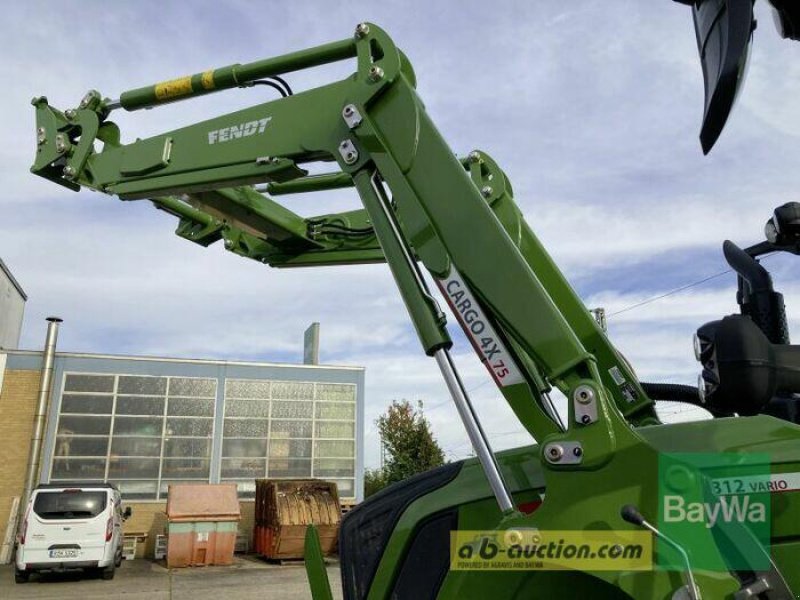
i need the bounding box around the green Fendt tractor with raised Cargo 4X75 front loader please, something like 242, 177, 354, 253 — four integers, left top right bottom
25, 0, 800, 600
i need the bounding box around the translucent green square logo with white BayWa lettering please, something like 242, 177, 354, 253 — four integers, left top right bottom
656, 453, 773, 571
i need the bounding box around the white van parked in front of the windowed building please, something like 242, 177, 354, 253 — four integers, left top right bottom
15, 482, 131, 583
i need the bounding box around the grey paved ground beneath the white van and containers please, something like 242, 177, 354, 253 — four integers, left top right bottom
0, 555, 342, 600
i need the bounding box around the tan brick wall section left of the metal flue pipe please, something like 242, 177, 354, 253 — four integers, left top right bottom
0, 368, 39, 538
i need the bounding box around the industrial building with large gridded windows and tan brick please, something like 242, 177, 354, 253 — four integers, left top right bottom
0, 288, 364, 556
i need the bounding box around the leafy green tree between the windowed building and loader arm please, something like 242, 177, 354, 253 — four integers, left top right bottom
376, 400, 444, 485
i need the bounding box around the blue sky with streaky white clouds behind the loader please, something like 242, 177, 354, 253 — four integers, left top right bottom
0, 0, 800, 464
